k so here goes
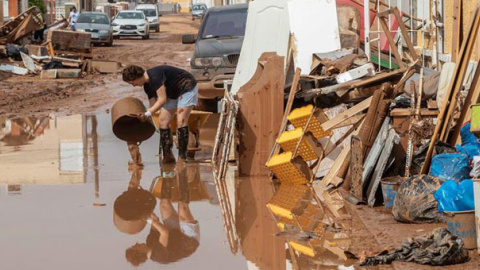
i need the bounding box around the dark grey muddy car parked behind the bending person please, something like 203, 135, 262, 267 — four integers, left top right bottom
182, 4, 248, 102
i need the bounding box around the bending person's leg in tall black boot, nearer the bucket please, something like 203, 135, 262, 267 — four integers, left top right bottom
158, 108, 175, 163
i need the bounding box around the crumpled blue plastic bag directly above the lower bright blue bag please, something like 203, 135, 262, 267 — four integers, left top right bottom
430, 153, 472, 182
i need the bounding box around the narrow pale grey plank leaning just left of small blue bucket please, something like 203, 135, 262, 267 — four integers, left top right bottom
367, 129, 400, 207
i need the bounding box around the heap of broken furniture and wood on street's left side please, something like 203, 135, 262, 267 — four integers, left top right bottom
0, 7, 120, 79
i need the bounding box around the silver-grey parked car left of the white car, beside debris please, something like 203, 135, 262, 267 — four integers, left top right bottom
76, 12, 113, 46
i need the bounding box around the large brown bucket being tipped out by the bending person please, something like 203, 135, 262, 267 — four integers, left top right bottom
112, 97, 155, 142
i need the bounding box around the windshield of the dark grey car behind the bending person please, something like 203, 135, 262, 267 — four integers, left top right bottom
202, 9, 247, 39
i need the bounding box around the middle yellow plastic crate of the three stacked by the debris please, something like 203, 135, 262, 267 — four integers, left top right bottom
277, 128, 322, 161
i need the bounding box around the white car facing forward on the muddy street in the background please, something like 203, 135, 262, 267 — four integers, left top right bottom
112, 10, 150, 39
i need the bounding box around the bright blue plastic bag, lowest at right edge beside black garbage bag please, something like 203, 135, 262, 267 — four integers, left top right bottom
433, 179, 475, 212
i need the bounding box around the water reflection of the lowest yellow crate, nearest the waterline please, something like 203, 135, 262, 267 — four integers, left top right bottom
267, 185, 312, 220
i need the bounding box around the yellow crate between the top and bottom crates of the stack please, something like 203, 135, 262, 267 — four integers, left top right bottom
277, 128, 319, 161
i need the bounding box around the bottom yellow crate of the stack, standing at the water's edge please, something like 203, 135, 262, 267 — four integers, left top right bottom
266, 151, 313, 184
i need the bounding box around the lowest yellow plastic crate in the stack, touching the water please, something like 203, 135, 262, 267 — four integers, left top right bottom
266, 151, 310, 184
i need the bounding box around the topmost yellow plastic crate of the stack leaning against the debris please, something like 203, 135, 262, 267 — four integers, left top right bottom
287, 105, 332, 139
